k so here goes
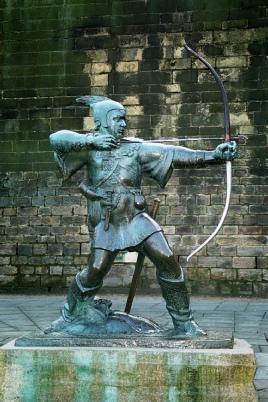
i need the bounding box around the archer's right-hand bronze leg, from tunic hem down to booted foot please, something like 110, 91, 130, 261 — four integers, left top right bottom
141, 232, 206, 336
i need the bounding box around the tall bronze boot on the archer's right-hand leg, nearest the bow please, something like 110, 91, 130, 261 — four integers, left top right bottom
158, 271, 206, 336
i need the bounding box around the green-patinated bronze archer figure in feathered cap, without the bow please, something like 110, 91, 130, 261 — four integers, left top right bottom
46, 96, 236, 337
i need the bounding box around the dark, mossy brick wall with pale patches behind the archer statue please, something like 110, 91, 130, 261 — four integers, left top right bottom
0, 0, 268, 296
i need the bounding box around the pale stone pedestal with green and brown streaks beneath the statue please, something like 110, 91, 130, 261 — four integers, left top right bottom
0, 339, 258, 402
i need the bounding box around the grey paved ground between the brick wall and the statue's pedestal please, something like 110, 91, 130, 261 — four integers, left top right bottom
0, 295, 268, 402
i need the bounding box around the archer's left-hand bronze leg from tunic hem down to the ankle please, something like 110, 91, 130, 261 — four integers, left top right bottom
62, 249, 117, 322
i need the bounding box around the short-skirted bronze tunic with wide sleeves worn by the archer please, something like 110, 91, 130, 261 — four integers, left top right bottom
54, 138, 173, 251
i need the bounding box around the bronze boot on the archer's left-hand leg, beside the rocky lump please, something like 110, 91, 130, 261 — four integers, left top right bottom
45, 273, 102, 333
